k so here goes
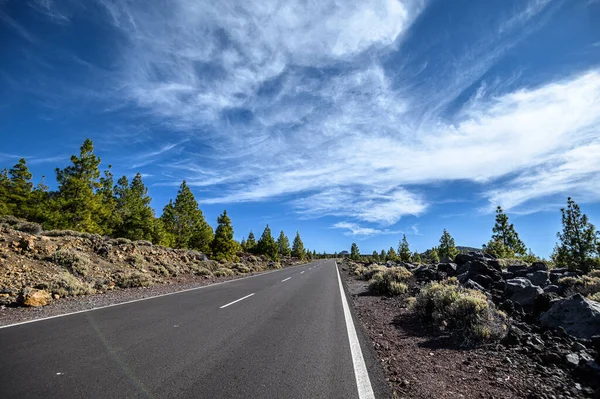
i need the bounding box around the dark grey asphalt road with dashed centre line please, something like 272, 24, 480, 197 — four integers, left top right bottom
0, 260, 387, 399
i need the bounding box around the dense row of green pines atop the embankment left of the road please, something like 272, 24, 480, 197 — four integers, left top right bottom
0, 139, 310, 260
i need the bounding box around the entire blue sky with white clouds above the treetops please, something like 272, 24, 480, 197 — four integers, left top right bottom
0, 0, 600, 256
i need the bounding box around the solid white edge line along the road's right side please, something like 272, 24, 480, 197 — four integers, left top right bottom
334, 261, 375, 399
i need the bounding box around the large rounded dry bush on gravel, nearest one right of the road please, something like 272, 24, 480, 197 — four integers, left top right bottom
412, 281, 507, 342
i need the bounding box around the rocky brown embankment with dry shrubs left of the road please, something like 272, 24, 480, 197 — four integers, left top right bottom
0, 219, 301, 307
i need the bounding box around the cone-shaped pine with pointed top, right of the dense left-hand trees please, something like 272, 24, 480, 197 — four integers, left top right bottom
161, 180, 213, 253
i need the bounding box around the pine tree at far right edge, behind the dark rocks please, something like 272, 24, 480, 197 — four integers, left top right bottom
552, 197, 598, 273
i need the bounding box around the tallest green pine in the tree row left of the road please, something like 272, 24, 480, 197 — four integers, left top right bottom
49, 139, 104, 234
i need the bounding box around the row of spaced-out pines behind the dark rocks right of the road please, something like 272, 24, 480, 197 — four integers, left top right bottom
350, 197, 600, 272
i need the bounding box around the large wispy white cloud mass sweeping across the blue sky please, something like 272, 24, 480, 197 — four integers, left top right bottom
21, 0, 600, 236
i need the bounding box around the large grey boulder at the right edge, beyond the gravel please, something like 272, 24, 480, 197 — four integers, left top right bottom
540, 294, 600, 339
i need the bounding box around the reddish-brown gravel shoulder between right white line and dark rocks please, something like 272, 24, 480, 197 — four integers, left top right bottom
340, 266, 585, 398
